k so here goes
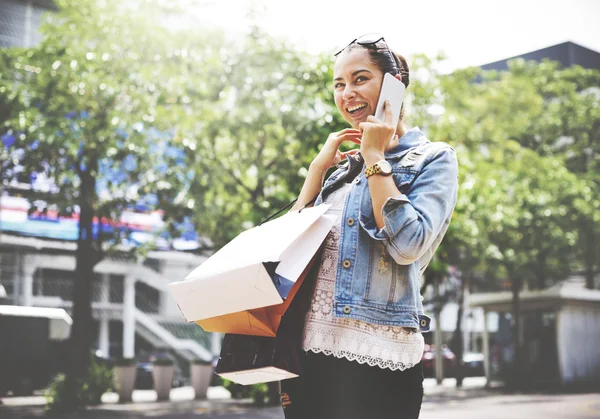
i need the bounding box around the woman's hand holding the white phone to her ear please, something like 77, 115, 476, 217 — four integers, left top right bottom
358, 100, 396, 165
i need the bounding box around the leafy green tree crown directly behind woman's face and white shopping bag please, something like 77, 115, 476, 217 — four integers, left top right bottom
178, 27, 347, 247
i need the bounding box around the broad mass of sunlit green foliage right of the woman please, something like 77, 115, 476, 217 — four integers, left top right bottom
409, 55, 600, 289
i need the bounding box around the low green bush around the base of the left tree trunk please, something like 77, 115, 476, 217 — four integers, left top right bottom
46, 358, 113, 412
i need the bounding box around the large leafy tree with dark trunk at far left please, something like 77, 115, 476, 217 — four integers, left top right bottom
0, 0, 202, 409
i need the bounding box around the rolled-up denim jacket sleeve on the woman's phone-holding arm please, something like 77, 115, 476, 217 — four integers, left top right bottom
367, 147, 458, 265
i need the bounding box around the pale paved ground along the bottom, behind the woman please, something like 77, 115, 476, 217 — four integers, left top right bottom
0, 379, 600, 419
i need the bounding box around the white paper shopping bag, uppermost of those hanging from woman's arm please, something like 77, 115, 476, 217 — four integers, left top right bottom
168, 204, 336, 322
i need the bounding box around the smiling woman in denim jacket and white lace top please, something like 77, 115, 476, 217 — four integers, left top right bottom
281, 36, 458, 419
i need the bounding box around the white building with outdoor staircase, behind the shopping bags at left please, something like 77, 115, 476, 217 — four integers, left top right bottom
0, 228, 219, 360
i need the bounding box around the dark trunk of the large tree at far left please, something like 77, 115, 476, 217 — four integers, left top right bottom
65, 160, 98, 410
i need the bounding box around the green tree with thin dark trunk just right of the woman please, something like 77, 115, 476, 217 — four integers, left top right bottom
424, 63, 592, 383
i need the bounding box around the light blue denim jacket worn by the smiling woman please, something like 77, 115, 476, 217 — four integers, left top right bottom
315, 128, 458, 332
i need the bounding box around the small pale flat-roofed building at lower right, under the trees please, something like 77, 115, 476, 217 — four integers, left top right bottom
469, 277, 600, 385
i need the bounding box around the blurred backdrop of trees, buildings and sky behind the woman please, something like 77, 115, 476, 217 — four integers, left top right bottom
0, 0, 600, 414
